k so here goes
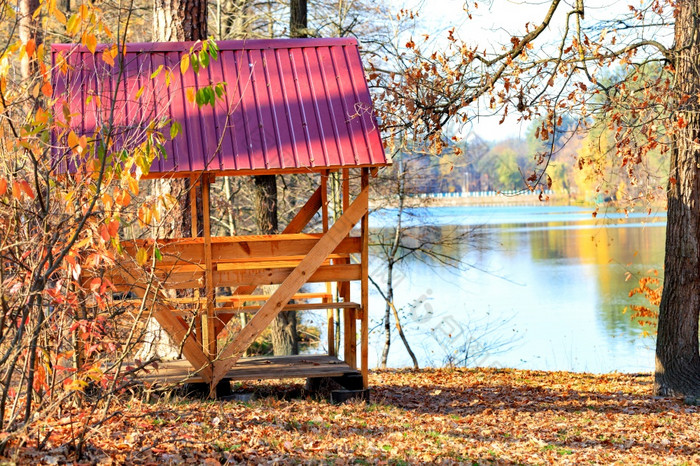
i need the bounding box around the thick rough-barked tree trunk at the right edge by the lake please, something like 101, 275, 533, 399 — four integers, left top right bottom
654, 0, 700, 396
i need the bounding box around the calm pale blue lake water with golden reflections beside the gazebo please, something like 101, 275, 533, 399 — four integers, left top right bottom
354, 206, 665, 373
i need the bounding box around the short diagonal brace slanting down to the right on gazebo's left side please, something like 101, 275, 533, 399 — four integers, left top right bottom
119, 268, 212, 382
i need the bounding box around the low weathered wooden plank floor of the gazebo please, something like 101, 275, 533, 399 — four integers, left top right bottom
139, 354, 360, 383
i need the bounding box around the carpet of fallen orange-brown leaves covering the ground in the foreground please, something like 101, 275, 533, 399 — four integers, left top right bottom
6, 369, 700, 464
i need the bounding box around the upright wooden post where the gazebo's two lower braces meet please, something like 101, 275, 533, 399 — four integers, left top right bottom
202, 174, 216, 359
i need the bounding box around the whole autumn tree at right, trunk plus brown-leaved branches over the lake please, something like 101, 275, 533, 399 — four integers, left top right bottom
370, 0, 700, 395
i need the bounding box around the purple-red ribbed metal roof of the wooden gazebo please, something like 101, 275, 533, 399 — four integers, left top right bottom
51, 38, 387, 176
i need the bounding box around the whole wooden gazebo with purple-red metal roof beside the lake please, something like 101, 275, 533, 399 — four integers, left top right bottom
52, 38, 387, 390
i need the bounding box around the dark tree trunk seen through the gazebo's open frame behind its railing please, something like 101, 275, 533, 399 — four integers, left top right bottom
253, 175, 299, 356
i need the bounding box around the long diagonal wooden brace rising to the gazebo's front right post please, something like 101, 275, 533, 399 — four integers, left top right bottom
211, 187, 368, 387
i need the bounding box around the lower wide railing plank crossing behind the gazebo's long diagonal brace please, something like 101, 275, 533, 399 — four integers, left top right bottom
214, 264, 362, 290
